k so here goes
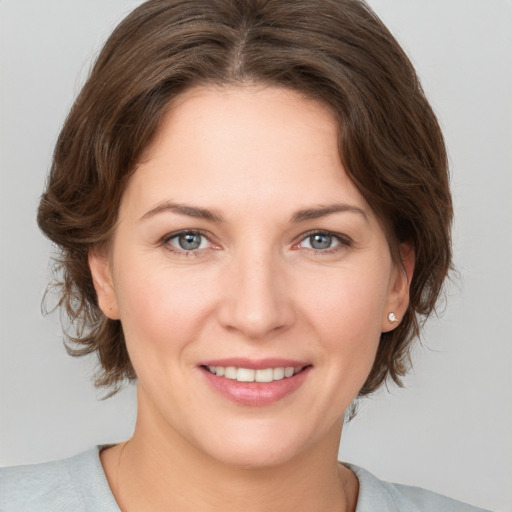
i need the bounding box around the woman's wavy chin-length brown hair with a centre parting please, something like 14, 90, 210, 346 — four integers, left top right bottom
38, 0, 452, 395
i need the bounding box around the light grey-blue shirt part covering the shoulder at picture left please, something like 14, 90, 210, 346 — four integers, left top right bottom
0, 448, 119, 512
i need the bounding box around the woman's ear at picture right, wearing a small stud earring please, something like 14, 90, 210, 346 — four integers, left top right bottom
381, 242, 415, 332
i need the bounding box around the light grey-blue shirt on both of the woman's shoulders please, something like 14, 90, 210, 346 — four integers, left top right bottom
0, 447, 488, 512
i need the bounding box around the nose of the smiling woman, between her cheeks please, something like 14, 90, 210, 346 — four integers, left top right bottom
219, 251, 295, 340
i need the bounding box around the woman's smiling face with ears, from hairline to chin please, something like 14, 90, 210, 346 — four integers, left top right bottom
90, 86, 407, 466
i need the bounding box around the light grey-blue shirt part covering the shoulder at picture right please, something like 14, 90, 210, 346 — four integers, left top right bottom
347, 464, 489, 512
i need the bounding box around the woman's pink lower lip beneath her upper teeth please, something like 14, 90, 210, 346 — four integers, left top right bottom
202, 366, 311, 406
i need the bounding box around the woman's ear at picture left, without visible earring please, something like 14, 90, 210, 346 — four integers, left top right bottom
88, 248, 119, 320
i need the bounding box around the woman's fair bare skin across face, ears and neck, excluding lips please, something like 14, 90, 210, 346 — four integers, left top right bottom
90, 85, 413, 511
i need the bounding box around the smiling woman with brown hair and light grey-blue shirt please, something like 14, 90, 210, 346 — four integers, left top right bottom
0, 0, 496, 512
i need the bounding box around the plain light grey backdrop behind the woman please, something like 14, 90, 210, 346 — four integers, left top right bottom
0, 0, 512, 511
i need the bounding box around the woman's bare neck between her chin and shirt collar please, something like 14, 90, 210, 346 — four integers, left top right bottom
102, 390, 358, 512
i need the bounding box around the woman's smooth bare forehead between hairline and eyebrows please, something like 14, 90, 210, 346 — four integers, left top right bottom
126, 85, 366, 218
